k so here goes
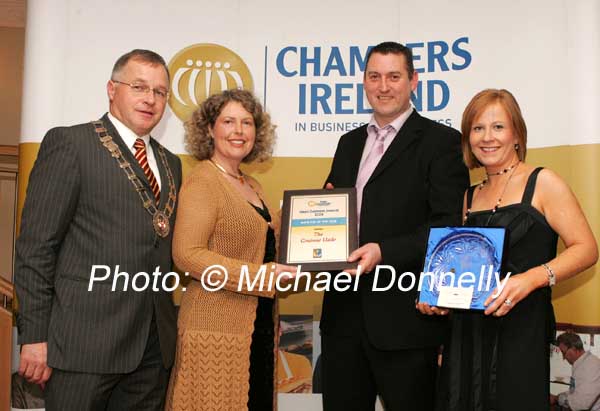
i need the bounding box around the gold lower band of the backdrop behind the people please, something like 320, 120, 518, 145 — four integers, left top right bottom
18, 143, 600, 325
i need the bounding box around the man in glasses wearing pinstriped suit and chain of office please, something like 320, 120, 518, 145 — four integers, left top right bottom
15, 50, 181, 411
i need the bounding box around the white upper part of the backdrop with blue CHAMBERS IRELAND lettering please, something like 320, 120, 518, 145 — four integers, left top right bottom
22, 0, 600, 153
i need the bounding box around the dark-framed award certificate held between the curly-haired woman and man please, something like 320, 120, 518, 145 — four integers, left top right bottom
279, 188, 358, 271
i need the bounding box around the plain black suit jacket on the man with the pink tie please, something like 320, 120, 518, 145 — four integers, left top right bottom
321, 111, 469, 350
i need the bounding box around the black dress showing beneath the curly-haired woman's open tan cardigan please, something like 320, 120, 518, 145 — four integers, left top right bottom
248, 202, 276, 411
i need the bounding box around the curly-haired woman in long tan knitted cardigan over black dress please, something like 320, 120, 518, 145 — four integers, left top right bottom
166, 90, 293, 411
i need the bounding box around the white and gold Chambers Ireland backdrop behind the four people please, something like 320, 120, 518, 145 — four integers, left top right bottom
19, 0, 600, 384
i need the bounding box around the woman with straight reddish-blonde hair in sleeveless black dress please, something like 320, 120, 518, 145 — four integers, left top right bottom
417, 89, 598, 411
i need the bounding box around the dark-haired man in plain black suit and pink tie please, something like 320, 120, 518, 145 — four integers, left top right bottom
321, 42, 469, 411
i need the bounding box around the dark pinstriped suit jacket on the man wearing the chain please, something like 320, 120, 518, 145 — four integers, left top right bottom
15, 115, 181, 373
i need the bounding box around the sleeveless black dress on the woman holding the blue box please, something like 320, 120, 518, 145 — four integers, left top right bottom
437, 168, 558, 411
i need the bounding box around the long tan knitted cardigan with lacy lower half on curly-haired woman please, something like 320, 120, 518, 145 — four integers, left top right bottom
166, 161, 278, 411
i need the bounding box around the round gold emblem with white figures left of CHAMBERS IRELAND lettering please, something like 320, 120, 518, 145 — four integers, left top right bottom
169, 44, 254, 121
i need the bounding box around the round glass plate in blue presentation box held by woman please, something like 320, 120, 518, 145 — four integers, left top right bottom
419, 227, 507, 310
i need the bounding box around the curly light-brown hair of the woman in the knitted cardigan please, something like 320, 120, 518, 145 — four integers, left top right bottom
185, 89, 275, 163
